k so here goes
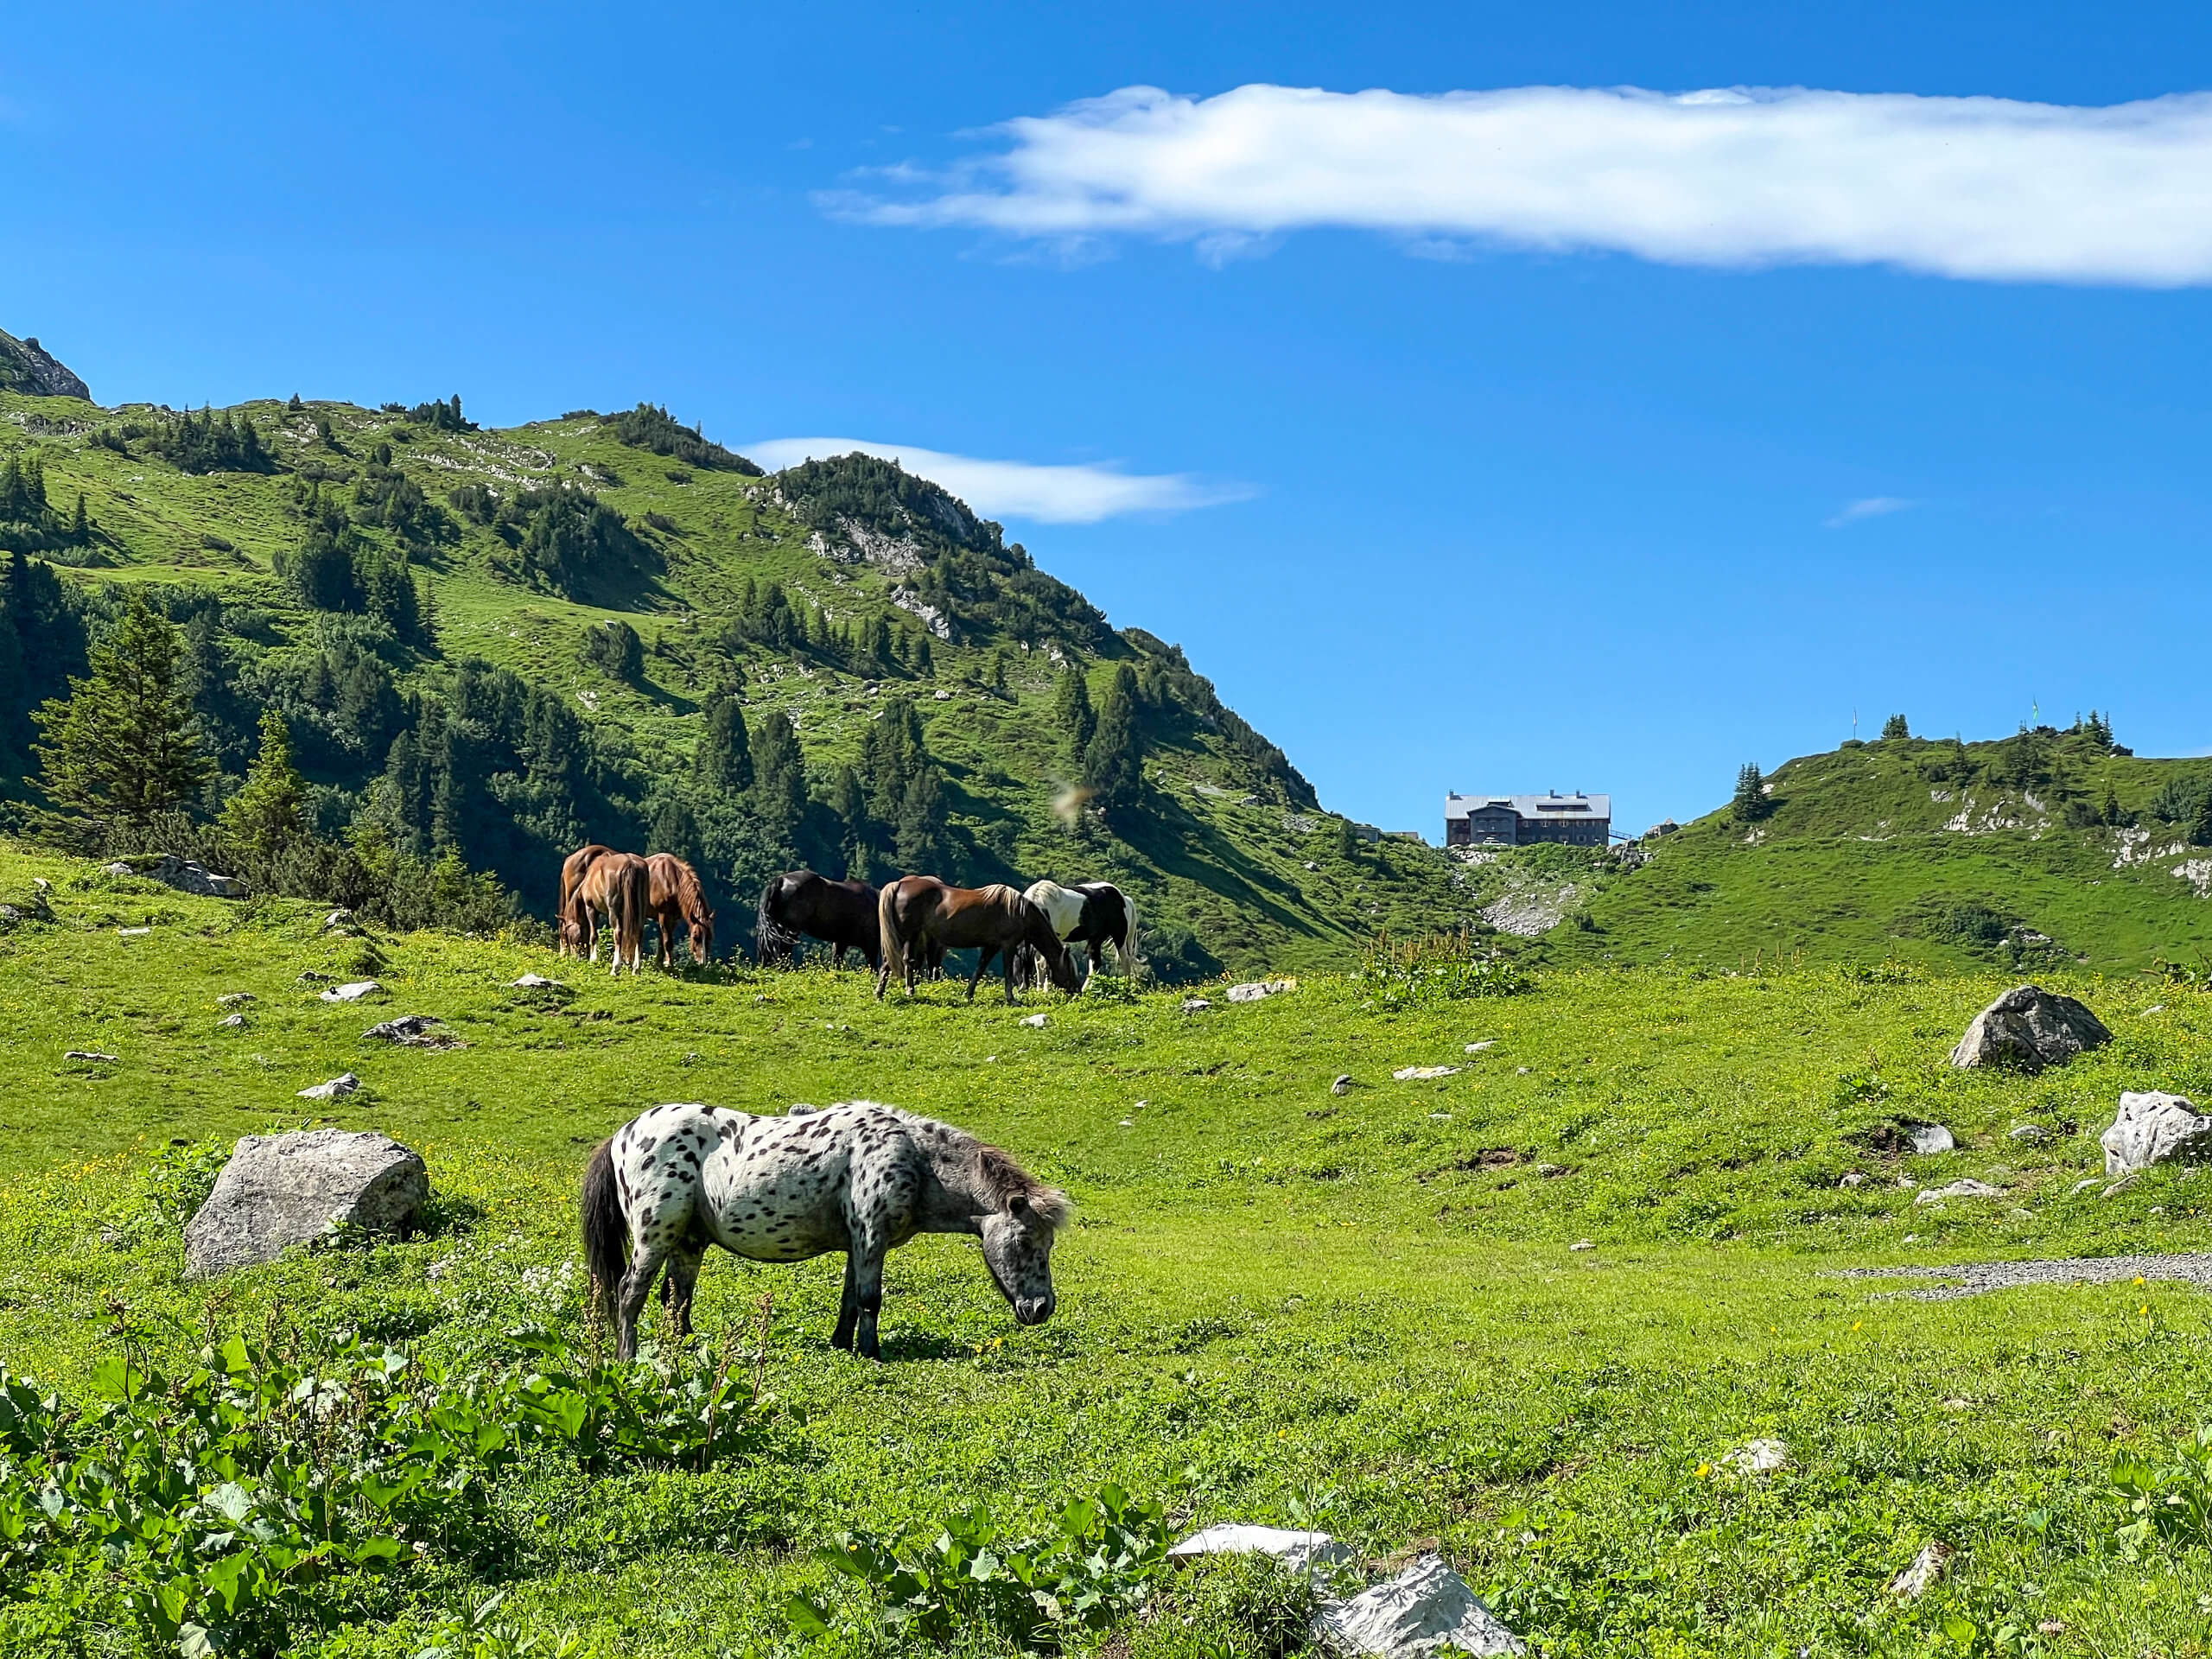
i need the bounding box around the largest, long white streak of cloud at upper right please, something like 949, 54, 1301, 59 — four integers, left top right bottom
823, 86, 2212, 288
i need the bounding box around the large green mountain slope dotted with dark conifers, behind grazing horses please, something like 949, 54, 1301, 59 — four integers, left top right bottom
13, 376, 1465, 976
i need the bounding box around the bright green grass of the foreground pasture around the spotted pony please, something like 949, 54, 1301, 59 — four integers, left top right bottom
0, 852, 2212, 1656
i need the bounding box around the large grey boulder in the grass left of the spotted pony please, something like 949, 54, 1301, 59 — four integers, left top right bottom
183, 1128, 429, 1279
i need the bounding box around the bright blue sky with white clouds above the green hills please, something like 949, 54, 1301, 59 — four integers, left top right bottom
0, 4, 2212, 838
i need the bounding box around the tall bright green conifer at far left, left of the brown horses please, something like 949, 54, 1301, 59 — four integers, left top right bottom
33, 593, 213, 827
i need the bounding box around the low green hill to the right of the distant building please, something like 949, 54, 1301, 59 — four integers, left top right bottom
1462, 730, 2212, 973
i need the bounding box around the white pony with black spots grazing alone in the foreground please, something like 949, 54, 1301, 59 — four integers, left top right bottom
584, 1099, 1071, 1360
